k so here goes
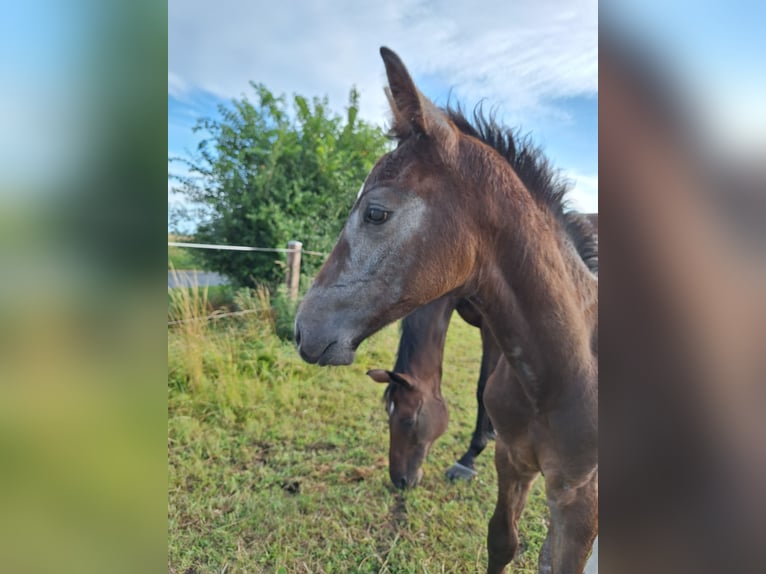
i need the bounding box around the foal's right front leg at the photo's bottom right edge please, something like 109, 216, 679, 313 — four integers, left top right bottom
546, 474, 598, 574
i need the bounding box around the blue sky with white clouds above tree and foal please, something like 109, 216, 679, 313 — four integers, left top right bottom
168, 0, 598, 233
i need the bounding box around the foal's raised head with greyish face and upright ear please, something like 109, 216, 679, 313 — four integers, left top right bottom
295, 48, 478, 365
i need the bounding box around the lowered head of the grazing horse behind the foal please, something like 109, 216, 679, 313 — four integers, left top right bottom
367, 369, 449, 488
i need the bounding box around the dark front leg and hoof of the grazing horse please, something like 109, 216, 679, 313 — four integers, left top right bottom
447, 329, 500, 480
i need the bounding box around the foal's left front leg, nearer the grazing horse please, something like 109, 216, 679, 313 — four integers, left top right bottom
487, 437, 537, 574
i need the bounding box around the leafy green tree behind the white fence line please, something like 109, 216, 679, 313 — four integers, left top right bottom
174, 83, 388, 286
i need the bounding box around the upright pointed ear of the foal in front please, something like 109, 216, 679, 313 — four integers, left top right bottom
380, 46, 457, 150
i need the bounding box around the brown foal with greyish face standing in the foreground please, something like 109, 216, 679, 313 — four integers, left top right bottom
295, 48, 598, 574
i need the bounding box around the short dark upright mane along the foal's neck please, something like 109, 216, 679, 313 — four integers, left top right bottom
444, 106, 598, 273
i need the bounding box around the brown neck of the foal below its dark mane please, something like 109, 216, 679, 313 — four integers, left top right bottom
464, 158, 598, 407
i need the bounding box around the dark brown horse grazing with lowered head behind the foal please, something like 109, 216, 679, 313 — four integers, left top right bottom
367, 295, 500, 488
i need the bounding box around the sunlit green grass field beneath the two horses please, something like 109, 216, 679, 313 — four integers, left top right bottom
168, 290, 548, 574
